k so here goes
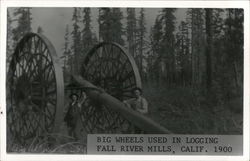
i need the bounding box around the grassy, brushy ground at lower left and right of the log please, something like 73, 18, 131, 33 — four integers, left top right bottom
7, 83, 243, 154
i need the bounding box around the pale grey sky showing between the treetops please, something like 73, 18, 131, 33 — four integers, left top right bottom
10, 7, 187, 56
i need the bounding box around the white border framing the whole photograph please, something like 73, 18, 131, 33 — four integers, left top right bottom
0, 0, 250, 161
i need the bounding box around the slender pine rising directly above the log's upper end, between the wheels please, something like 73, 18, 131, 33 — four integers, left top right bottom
71, 7, 81, 73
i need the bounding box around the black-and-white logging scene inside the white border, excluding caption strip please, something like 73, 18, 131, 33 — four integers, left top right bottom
1, 2, 245, 155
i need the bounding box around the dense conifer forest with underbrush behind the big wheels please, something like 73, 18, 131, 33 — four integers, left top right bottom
7, 8, 244, 134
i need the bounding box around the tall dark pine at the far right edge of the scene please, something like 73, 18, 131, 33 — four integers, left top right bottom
224, 9, 244, 92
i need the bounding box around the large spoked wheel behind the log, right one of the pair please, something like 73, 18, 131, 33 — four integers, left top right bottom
81, 42, 141, 133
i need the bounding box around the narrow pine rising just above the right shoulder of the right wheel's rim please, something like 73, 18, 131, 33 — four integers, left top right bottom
126, 8, 137, 57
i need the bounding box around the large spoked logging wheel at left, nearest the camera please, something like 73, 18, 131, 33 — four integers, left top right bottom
7, 33, 64, 144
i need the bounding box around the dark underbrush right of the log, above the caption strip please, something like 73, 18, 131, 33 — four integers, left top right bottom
143, 86, 243, 134
